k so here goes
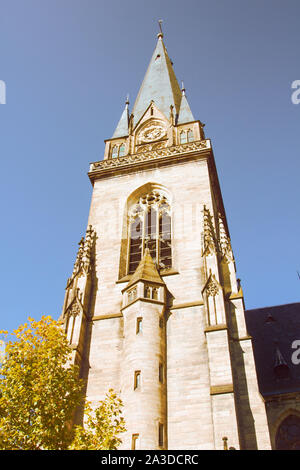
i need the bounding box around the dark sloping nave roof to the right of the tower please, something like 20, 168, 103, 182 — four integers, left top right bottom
245, 303, 300, 397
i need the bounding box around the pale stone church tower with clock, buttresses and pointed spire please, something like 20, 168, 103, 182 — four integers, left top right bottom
62, 27, 270, 449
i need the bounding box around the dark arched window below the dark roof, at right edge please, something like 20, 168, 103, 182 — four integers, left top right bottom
274, 409, 300, 450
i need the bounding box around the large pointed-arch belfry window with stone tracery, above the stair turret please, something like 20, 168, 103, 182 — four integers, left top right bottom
127, 190, 172, 274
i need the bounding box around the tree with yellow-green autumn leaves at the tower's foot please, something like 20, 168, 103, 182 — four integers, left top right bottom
0, 317, 124, 450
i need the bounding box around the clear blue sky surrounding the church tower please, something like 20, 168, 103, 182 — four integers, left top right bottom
0, 0, 300, 330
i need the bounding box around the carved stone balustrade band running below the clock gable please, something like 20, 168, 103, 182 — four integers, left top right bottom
88, 139, 211, 181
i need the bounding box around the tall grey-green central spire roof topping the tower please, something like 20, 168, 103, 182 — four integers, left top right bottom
132, 33, 181, 126
